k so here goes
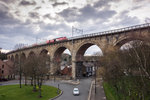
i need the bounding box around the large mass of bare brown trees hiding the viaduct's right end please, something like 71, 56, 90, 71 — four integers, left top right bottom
100, 35, 150, 100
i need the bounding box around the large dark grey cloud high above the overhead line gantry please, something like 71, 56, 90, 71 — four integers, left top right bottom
58, 5, 116, 22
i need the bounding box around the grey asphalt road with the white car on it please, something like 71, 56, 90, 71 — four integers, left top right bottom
0, 78, 91, 100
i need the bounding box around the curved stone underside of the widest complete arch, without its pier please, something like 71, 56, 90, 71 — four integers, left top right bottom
74, 41, 104, 61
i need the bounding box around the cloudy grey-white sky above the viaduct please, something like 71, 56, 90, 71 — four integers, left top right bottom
0, 0, 150, 52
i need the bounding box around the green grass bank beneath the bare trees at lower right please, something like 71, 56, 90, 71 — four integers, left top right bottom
103, 76, 150, 100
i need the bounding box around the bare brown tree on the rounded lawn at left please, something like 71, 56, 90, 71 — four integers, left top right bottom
24, 55, 49, 97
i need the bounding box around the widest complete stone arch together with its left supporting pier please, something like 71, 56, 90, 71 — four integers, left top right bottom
72, 40, 105, 77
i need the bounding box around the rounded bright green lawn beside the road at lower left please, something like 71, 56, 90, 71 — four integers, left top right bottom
0, 85, 57, 100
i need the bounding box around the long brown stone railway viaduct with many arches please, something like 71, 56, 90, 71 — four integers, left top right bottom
7, 23, 150, 78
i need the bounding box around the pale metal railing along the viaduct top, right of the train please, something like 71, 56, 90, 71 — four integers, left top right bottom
68, 23, 150, 40
